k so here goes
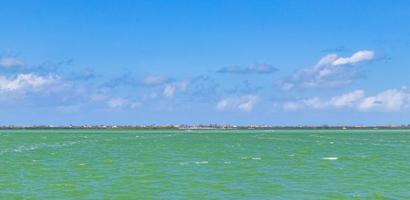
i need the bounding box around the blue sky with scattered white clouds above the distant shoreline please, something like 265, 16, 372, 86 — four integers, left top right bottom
0, 0, 410, 125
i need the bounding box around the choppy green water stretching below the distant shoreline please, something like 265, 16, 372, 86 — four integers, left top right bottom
0, 130, 410, 199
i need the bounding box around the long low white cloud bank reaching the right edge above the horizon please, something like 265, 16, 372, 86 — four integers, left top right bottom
283, 87, 410, 112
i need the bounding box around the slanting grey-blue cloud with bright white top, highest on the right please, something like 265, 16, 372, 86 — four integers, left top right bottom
281, 50, 375, 90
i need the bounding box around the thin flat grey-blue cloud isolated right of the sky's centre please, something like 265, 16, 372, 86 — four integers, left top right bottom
218, 64, 278, 74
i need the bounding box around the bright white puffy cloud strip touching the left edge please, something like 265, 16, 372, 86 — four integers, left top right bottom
0, 73, 61, 92
